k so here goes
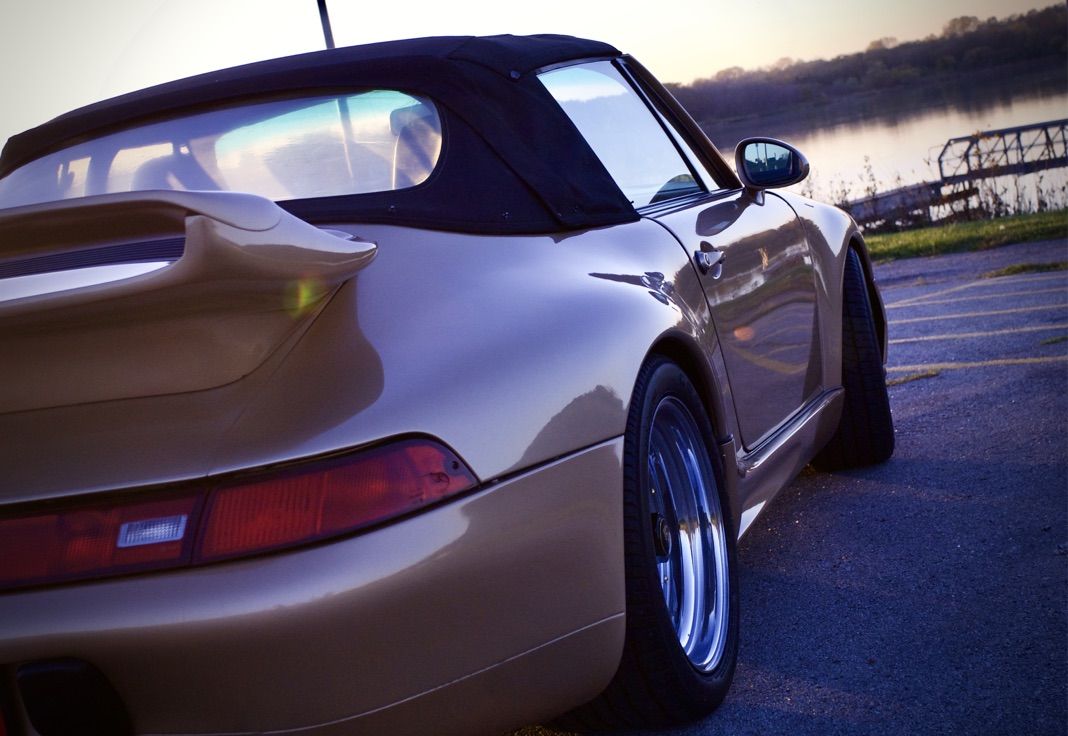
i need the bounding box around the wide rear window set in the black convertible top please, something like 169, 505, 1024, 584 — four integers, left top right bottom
0, 90, 441, 207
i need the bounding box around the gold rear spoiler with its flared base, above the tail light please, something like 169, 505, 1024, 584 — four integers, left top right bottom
0, 191, 376, 411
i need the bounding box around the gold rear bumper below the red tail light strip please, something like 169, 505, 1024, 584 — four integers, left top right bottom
0, 438, 625, 735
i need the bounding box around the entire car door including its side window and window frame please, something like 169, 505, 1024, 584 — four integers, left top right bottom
540, 61, 821, 449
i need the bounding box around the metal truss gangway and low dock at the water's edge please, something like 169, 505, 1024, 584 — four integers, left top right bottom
844, 119, 1068, 225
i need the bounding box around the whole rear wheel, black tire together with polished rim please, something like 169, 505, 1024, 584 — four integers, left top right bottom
555, 358, 738, 731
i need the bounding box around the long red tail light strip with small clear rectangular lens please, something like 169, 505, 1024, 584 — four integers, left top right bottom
0, 440, 476, 589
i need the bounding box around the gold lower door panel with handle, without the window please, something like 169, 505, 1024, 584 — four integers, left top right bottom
655, 190, 820, 448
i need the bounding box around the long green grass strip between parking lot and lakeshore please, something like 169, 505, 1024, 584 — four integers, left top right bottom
864, 209, 1068, 261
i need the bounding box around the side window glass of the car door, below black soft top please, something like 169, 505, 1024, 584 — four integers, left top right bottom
538, 61, 705, 207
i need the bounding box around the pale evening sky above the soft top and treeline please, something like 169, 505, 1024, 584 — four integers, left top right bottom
0, 0, 1051, 142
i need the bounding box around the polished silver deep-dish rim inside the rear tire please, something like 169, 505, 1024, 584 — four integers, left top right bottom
648, 396, 729, 672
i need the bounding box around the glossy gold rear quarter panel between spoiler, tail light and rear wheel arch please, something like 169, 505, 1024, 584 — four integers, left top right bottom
213, 216, 707, 481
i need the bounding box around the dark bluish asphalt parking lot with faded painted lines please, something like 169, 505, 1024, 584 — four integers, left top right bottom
519, 240, 1068, 736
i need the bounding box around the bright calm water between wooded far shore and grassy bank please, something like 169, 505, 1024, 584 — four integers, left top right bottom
724, 93, 1068, 208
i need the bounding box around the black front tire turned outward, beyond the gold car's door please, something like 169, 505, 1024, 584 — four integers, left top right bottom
813, 243, 894, 470
